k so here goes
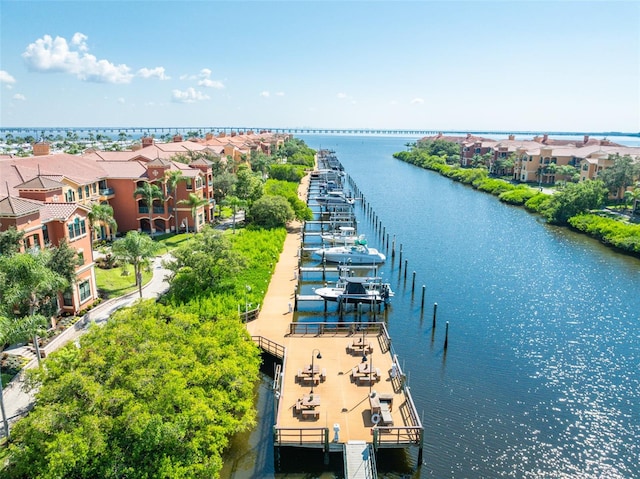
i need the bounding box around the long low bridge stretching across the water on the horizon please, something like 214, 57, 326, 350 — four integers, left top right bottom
0, 126, 640, 138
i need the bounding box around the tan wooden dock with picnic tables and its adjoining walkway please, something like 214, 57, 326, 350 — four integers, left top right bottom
247, 149, 424, 479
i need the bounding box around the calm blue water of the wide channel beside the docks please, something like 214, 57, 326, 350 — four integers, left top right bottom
221, 136, 640, 478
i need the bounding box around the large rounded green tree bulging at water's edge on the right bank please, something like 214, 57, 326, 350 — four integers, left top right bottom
544, 180, 607, 225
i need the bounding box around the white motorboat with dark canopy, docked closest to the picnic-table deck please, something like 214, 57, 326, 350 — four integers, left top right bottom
315, 277, 393, 304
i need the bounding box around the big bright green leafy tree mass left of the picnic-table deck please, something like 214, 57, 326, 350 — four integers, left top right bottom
0, 301, 260, 479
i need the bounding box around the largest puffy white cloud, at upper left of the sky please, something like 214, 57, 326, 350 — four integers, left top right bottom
22, 33, 133, 83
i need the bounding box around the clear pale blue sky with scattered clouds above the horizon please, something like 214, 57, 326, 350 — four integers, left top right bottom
0, 0, 640, 132
